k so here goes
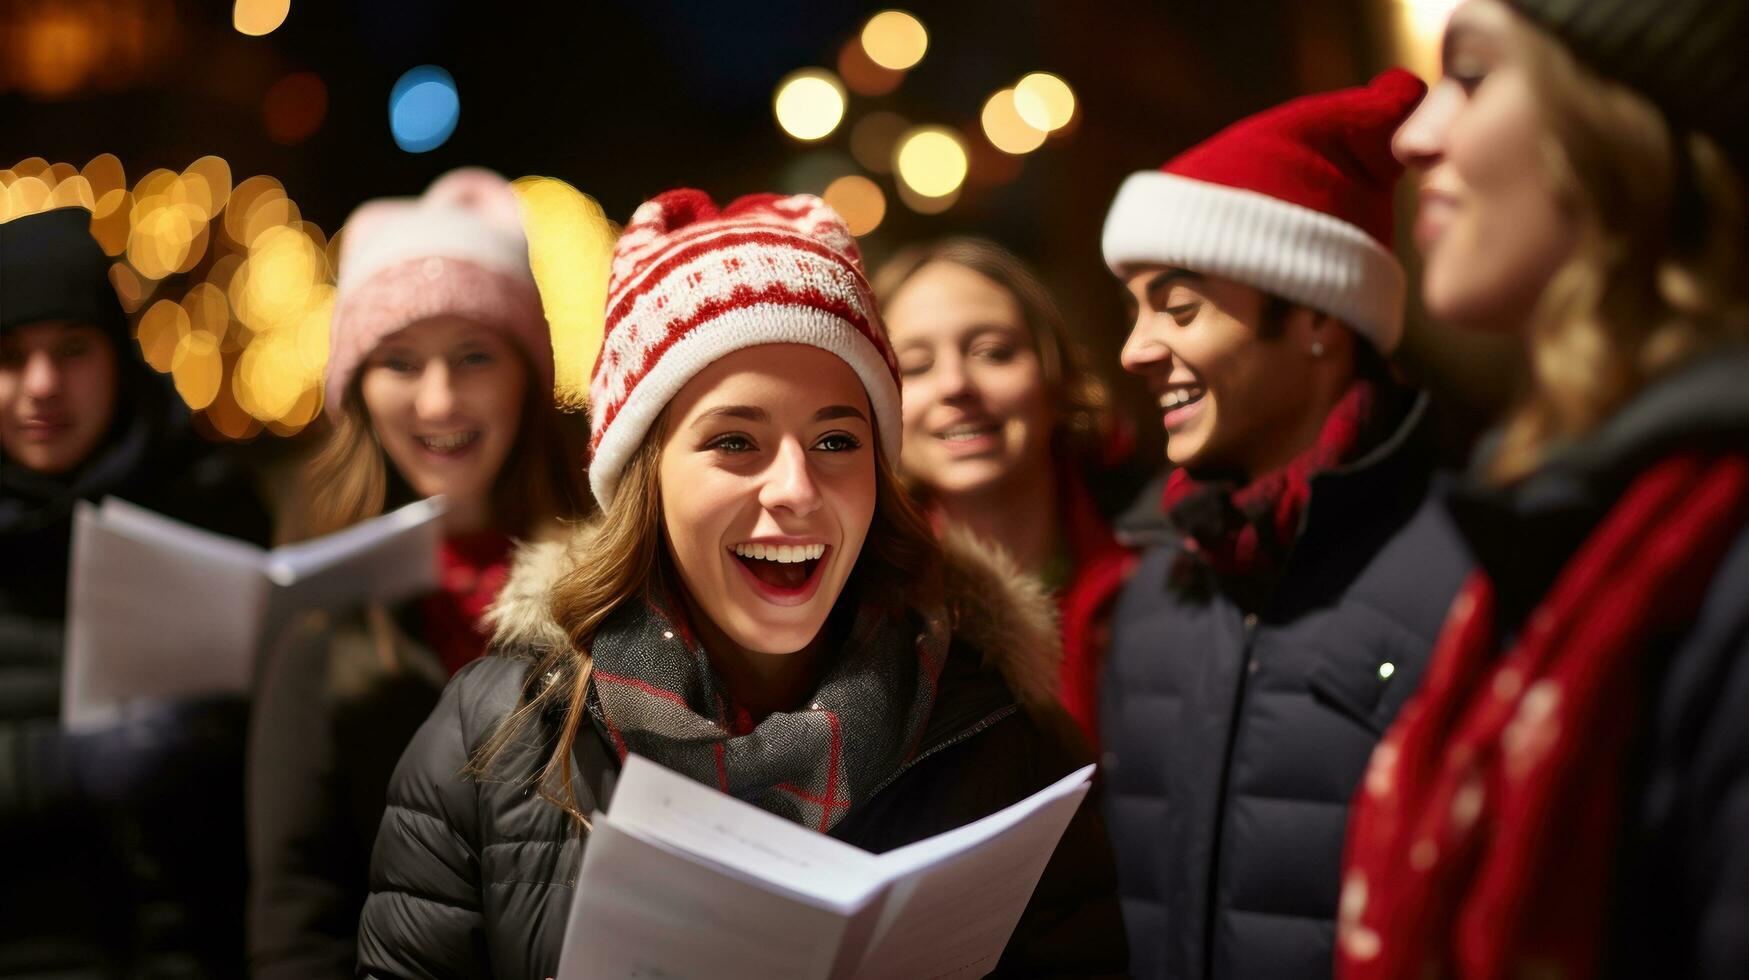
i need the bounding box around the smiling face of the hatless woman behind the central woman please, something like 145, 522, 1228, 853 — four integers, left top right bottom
885, 263, 1055, 495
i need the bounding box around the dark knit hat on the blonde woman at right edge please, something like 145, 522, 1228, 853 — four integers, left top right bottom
1508, 0, 1749, 159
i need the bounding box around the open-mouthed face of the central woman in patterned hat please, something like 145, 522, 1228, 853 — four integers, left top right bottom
658, 345, 878, 655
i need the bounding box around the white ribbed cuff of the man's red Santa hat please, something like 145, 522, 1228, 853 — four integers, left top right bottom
1102, 170, 1406, 352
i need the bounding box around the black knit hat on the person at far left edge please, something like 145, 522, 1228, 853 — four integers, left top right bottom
0, 208, 133, 350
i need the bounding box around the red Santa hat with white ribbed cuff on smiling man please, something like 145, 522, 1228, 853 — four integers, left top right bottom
1104, 68, 1427, 352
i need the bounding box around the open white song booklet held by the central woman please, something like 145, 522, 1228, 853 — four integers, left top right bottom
558, 756, 1093, 980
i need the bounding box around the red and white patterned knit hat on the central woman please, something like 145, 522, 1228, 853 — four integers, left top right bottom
589, 189, 899, 508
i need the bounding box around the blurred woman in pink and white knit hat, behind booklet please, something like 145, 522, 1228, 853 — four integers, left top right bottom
248, 170, 588, 978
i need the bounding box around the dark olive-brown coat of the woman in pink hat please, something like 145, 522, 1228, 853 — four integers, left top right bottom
248, 600, 449, 980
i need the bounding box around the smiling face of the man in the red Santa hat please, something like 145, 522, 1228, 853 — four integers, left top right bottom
1121, 266, 1341, 476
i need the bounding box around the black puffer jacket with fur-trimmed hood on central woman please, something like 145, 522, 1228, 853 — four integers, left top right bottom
359, 532, 1125, 978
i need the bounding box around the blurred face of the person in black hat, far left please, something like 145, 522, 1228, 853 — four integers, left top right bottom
0, 320, 117, 476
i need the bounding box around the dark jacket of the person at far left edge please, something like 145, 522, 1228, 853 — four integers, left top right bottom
0, 383, 269, 977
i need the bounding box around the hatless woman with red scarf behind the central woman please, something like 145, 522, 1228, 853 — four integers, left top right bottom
875, 238, 1133, 744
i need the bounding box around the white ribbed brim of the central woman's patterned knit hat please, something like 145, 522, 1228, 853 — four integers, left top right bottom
589, 303, 901, 509
